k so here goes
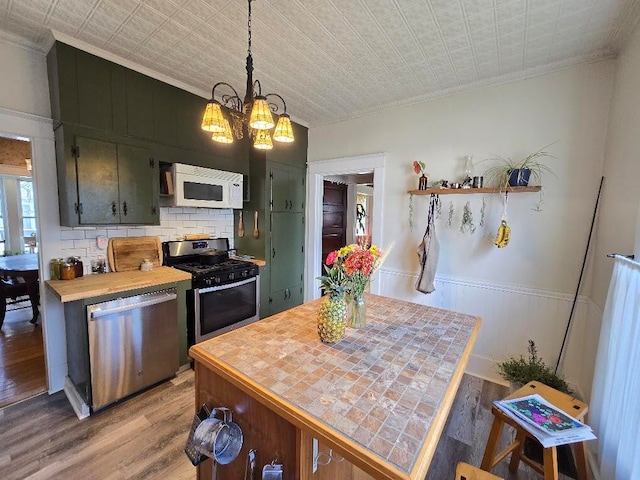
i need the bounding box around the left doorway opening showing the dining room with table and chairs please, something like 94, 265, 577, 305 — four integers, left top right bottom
0, 136, 47, 408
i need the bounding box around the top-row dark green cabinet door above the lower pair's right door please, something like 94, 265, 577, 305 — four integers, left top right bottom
126, 70, 153, 140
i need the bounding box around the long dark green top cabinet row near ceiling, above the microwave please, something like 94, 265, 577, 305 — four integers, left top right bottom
47, 42, 249, 174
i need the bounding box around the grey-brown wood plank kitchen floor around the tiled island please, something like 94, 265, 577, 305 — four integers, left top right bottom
0, 370, 566, 480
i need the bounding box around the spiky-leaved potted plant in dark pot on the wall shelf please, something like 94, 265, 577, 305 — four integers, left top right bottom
483, 145, 556, 188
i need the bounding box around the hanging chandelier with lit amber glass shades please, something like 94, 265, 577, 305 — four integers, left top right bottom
202, 0, 293, 150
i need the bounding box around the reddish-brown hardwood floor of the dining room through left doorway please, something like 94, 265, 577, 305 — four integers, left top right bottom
0, 308, 47, 408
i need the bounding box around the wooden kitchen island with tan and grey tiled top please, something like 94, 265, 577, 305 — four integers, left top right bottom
190, 295, 481, 479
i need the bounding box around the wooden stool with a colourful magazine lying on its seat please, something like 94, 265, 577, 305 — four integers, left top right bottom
480, 382, 588, 480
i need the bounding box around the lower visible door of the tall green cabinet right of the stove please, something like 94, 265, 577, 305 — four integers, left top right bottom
268, 212, 304, 292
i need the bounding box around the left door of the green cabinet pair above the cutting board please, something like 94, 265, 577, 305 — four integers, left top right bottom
75, 137, 120, 225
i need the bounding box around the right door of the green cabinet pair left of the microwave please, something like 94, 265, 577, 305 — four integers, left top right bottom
118, 145, 160, 225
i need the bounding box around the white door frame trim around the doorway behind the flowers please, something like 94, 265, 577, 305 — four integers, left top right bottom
304, 153, 386, 302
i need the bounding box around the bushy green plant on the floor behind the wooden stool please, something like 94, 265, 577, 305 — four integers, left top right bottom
496, 340, 573, 394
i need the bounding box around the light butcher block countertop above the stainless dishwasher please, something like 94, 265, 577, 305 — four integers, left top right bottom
46, 267, 191, 303
